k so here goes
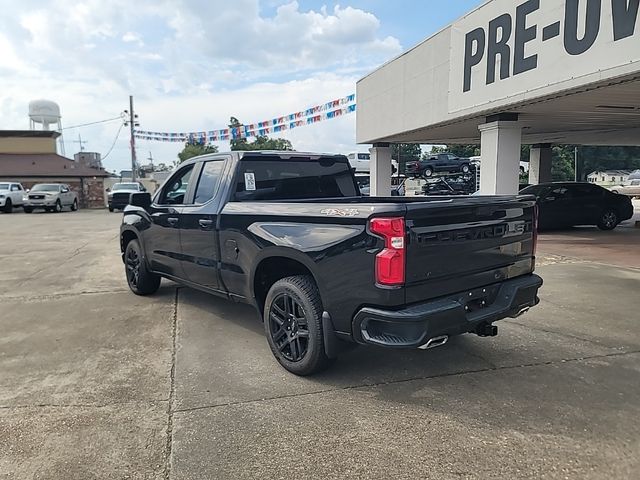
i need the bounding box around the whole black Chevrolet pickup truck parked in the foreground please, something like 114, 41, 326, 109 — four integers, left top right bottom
120, 152, 542, 375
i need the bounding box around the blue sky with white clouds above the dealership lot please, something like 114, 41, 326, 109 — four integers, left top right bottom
0, 0, 482, 171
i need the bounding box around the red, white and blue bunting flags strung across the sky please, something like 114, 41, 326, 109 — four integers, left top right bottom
134, 94, 356, 144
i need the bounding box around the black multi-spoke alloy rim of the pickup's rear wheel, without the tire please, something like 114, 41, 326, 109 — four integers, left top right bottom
269, 293, 309, 362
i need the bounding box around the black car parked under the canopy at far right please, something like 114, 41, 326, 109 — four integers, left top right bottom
520, 182, 633, 230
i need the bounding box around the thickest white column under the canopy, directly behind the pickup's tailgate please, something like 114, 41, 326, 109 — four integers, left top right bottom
478, 121, 522, 195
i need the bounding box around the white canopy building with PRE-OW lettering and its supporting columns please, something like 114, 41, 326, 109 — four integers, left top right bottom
356, 0, 640, 195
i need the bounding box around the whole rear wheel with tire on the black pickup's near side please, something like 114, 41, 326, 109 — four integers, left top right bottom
263, 275, 332, 376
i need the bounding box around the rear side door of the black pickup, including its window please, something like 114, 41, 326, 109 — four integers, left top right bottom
180, 157, 227, 290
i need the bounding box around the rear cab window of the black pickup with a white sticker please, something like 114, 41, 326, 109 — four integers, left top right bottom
234, 156, 360, 201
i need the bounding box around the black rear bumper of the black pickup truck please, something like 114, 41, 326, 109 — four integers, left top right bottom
352, 274, 542, 348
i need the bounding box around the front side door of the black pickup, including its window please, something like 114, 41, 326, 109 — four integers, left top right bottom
144, 164, 195, 278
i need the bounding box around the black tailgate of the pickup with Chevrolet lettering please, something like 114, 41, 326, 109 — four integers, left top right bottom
406, 196, 535, 304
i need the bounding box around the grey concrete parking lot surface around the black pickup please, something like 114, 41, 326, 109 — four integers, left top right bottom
0, 211, 640, 480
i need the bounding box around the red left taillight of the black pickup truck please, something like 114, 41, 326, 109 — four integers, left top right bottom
369, 218, 405, 285
